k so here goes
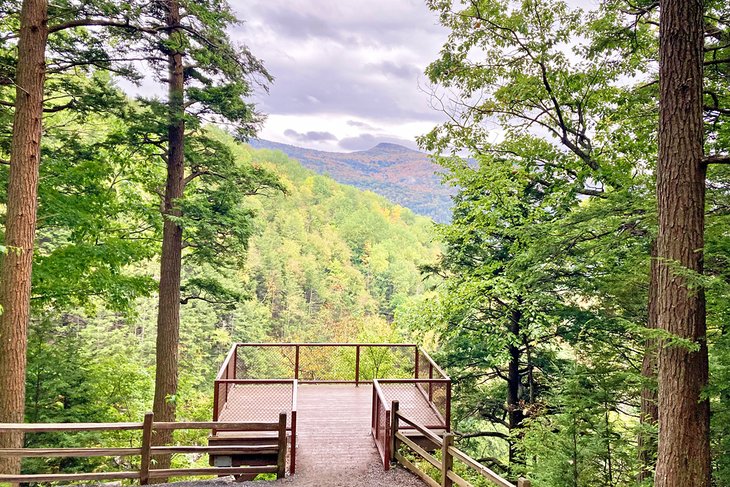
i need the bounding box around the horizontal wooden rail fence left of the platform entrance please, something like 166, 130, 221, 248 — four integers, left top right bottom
0, 413, 287, 485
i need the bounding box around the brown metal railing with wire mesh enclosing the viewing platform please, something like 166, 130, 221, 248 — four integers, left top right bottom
213, 343, 451, 473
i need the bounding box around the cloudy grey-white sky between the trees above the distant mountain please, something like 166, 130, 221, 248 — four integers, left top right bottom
232, 0, 447, 152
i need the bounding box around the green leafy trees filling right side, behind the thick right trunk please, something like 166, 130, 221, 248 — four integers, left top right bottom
416, 0, 728, 486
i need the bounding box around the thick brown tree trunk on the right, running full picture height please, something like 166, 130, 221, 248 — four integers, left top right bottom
655, 0, 710, 487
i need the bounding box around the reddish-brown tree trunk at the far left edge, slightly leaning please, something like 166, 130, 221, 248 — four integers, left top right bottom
0, 0, 48, 473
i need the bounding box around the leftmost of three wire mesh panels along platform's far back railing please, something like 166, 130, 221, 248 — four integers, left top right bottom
235, 345, 296, 379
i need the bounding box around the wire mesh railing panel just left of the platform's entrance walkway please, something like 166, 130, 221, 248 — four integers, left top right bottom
217, 382, 294, 426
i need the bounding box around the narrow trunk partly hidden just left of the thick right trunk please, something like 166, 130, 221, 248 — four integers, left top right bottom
637, 241, 659, 482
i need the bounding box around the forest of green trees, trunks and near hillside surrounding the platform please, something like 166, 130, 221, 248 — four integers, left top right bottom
0, 0, 730, 487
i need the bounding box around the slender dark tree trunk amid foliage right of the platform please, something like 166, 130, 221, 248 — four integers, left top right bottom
507, 299, 525, 469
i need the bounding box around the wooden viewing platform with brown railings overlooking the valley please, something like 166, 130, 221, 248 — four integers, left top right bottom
209, 343, 451, 476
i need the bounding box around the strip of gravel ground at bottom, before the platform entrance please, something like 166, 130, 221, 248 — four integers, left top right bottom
156, 465, 425, 487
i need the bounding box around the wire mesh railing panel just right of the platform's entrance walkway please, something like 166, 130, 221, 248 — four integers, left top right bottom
380, 380, 448, 428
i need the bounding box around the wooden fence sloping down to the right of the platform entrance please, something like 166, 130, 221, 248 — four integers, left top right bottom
389, 401, 530, 487
